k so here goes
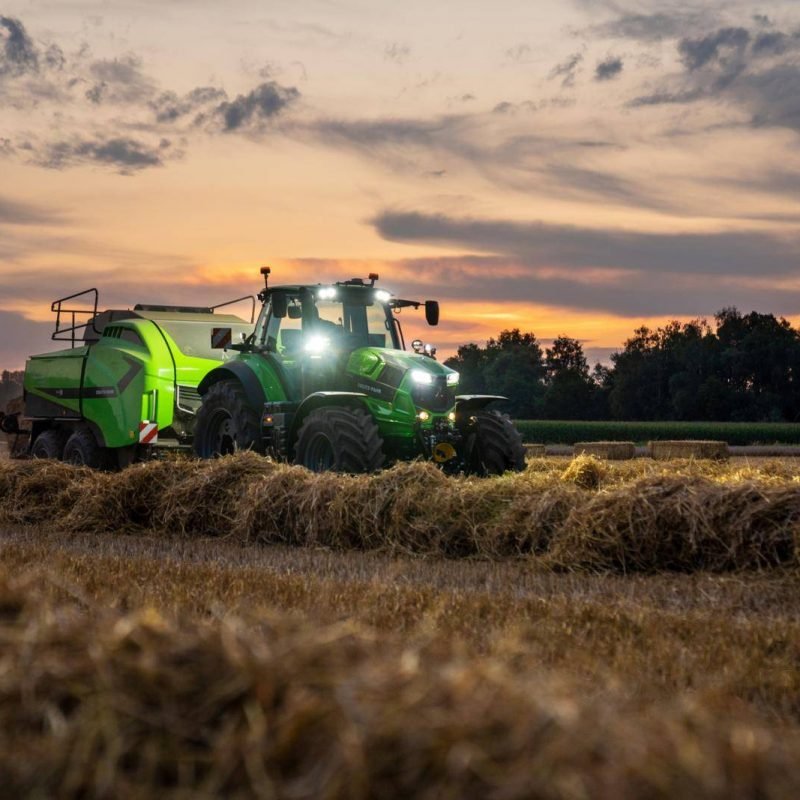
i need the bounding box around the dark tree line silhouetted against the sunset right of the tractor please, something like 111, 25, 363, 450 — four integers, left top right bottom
445, 308, 800, 422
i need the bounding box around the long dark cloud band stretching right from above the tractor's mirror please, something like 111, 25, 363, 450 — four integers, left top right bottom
371, 212, 800, 278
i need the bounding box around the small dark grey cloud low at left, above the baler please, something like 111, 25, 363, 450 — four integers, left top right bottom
35, 137, 170, 174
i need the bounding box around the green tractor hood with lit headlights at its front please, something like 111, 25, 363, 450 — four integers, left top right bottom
347, 347, 458, 409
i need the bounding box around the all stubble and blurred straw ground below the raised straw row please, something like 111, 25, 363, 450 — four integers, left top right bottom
0, 527, 800, 799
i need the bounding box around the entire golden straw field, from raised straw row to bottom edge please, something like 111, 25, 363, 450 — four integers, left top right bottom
0, 454, 800, 798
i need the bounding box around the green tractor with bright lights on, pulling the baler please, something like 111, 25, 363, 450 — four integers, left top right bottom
194, 267, 525, 475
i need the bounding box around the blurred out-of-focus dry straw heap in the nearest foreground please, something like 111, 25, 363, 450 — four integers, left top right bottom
0, 577, 800, 800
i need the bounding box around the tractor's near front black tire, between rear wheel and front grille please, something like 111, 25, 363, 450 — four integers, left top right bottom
294, 407, 384, 473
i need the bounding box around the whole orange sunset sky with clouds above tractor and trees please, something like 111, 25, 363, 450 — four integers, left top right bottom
0, 0, 800, 368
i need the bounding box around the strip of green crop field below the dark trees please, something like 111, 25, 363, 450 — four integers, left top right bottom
516, 420, 800, 445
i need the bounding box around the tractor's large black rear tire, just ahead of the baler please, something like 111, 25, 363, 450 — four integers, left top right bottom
194, 380, 262, 458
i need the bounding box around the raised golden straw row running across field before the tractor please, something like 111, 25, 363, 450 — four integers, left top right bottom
0, 453, 800, 572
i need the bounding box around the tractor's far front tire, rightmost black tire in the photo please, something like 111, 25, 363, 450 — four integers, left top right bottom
464, 411, 525, 475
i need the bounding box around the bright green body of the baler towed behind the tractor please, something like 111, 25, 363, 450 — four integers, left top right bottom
25, 311, 252, 448
